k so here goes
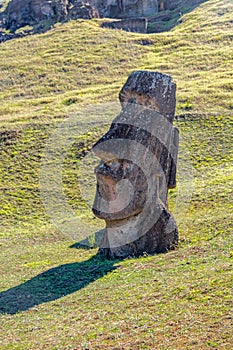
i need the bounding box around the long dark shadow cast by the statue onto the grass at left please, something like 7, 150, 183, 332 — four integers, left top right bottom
0, 256, 117, 314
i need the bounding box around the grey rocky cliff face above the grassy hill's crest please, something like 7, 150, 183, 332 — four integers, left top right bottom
0, 0, 206, 32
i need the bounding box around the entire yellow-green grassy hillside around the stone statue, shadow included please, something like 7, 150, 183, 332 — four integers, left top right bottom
0, 0, 233, 350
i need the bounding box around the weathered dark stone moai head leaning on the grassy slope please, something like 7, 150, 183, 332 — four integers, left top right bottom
92, 71, 179, 259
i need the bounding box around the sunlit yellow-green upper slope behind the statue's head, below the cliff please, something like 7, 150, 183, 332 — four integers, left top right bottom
0, 1, 232, 124
